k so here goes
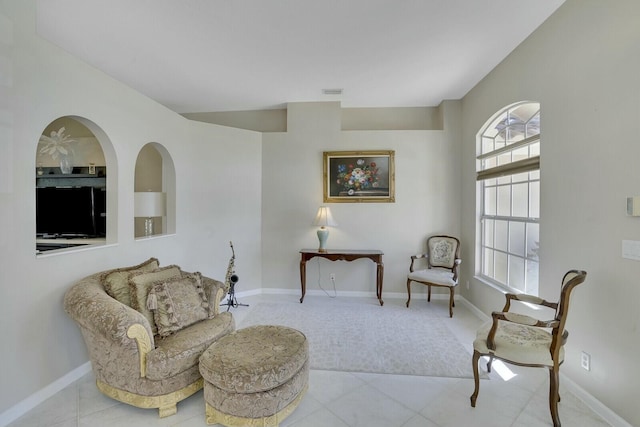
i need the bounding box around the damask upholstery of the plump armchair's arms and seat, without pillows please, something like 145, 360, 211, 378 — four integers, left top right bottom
64, 272, 235, 402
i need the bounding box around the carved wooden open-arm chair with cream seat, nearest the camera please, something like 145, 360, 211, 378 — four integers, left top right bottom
471, 270, 587, 427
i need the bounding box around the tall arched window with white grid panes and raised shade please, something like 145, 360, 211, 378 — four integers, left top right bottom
477, 102, 540, 295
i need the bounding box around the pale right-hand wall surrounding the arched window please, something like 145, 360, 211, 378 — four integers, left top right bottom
462, 0, 640, 425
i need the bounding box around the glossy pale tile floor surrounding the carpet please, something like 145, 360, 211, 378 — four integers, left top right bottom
9, 295, 609, 427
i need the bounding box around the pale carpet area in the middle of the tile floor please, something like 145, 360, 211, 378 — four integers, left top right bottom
238, 298, 480, 378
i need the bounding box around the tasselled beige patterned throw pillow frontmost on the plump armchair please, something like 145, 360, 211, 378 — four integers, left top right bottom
147, 273, 209, 337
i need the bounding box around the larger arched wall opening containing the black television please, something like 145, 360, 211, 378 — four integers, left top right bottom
35, 115, 118, 254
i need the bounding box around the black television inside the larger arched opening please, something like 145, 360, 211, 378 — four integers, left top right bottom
36, 187, 106, 237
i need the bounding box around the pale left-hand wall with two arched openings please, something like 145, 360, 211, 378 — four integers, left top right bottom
0, 0, 261, 414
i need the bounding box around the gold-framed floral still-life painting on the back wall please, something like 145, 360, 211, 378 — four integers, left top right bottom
323, 151, 395, 203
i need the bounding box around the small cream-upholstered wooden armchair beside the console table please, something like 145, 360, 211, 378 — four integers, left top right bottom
407, 236, 462, 317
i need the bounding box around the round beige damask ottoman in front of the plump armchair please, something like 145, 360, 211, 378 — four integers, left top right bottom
200, 325, 309, 427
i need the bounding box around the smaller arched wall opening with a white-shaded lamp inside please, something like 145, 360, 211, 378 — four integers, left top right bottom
134, 142, 176, 238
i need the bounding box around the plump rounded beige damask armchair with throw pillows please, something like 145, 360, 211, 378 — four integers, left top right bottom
64, 258, 235, 417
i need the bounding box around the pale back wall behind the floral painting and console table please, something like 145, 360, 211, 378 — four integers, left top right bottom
262, 102, 460, 298
